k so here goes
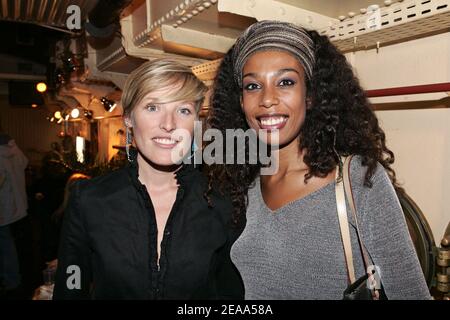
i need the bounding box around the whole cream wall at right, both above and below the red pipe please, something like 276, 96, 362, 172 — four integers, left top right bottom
346, 32, 450, 244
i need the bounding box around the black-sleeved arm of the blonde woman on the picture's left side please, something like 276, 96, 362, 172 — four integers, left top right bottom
53, 182, 91, 300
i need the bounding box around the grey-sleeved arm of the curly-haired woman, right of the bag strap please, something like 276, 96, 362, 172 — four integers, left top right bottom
362, 164, 431, 299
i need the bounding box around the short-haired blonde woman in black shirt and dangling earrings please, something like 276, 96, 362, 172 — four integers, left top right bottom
53, 60, 243, 299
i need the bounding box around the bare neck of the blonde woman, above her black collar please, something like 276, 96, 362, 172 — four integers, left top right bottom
137, 154, 180, 189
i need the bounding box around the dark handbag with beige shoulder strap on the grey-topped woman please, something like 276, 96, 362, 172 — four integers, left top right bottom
336, 156, 387, 300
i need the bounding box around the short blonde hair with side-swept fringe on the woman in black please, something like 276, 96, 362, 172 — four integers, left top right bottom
122, 59, 208, 116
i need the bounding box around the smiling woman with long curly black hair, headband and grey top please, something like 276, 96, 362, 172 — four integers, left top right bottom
208, 21, 430, 299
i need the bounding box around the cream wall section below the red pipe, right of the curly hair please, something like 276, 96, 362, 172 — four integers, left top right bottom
377, 109, 450, 244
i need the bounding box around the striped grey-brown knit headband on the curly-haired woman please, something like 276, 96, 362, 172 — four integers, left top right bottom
232, 20, 315, 87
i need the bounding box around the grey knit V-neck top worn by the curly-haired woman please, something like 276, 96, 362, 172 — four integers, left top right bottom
231, 157, 431, 299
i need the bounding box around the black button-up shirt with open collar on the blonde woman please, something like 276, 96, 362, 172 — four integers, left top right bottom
53, 163, 243, 299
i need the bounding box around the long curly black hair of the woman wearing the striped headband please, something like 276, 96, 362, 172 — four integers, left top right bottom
206, 31, 398, 220
